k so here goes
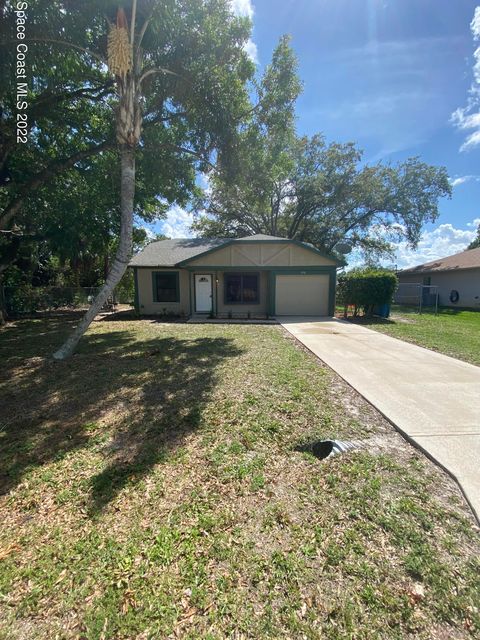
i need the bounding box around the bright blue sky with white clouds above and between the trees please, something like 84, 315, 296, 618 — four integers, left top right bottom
156, 0, 480, 268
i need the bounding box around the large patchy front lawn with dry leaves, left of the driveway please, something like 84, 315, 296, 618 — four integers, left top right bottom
0, 318, 480, 640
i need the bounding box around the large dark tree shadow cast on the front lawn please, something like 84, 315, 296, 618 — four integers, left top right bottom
0, 318, 241, 514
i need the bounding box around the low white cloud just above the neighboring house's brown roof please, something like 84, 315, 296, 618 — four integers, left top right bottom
395, 218, 480, 269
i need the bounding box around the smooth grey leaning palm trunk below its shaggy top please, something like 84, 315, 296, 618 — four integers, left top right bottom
53, 145, 135, 360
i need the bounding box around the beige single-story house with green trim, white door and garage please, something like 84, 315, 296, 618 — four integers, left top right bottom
129, 235, 340, 317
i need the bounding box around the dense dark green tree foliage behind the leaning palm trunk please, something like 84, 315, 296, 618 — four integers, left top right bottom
0, 0, 254, 284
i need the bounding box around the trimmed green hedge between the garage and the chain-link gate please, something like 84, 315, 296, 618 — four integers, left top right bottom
337, 269, 398, 315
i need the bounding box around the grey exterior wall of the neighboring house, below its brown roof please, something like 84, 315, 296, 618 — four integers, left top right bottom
399, 269, 480, 309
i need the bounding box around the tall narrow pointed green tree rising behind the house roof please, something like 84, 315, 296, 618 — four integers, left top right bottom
194, 36, 301, 238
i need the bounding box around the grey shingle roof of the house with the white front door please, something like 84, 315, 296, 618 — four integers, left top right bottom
129, 233, 313, 267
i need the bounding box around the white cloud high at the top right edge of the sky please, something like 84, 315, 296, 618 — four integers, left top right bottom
451, 6, 480, 151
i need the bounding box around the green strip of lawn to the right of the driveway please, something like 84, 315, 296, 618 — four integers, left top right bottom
348, 306, 480, 365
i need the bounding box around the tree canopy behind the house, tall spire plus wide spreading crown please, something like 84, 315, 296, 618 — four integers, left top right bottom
194, 50, 451, 259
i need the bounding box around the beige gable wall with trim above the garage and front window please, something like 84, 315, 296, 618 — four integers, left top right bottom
188, 242, 335, 267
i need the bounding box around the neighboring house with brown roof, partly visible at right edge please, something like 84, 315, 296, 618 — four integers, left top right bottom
397, 248, 480, 309
